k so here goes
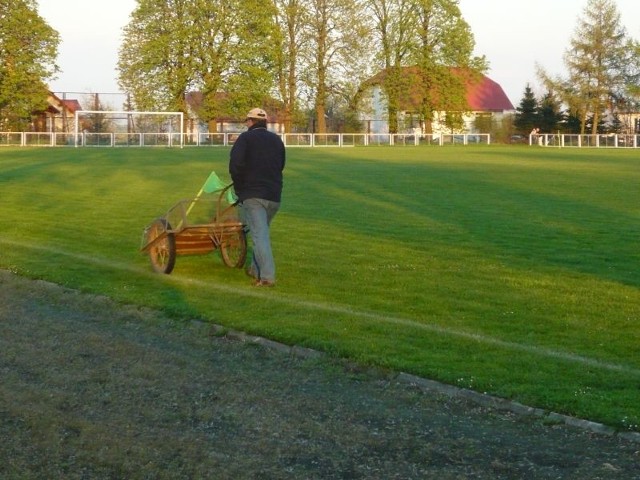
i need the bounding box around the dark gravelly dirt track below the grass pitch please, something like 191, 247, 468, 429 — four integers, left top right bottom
0, 271, 640, 480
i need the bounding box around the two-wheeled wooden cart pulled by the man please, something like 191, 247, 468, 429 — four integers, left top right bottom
140, 185, 247, 274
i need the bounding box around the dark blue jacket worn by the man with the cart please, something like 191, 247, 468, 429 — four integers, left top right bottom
229, 125, 285, 202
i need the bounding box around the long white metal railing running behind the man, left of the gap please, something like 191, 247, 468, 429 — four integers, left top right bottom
0, 132, 491, 147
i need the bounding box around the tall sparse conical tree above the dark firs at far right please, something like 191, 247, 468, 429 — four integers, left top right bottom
539, 0, 632, 134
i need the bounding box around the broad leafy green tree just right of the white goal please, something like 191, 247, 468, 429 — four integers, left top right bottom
118, 0, 275, 130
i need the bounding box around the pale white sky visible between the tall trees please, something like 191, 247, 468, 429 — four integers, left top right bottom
38, 0, 640, 106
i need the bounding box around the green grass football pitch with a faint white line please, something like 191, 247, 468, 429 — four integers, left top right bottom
0, 146, 640, 431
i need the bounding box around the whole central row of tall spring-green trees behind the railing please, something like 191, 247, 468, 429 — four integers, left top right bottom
119, 0, 486, 132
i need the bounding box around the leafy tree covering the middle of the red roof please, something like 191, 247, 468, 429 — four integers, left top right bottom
413, 0, 487, 133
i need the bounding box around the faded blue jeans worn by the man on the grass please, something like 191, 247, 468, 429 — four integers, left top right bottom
240, 198, 280, 282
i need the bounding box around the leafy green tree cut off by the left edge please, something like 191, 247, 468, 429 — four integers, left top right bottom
0, 0, 60, 130
